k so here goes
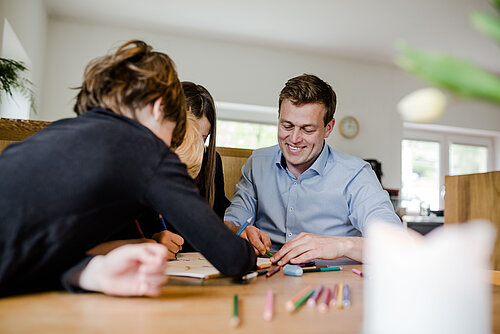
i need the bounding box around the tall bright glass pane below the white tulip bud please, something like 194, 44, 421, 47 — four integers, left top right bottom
401, 139, 440, 213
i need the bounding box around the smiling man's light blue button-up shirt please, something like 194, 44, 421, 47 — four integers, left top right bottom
224, 142, 401, 251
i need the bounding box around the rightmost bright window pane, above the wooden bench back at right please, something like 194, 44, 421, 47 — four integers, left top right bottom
450, 144, 488, 175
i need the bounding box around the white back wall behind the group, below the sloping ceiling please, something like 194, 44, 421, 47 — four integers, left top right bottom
40, 19, 500, 188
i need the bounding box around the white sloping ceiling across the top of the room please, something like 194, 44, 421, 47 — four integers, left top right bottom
45, 0, 500, 71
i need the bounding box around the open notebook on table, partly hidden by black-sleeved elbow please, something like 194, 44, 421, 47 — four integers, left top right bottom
165, 252, 271, 279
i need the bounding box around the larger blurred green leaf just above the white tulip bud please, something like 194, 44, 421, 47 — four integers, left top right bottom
396, 44, 500, 104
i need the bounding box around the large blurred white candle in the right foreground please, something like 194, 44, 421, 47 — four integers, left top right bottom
363, 221, 496, 334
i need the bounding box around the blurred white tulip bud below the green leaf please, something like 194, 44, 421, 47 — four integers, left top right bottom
398, 88, 446, 123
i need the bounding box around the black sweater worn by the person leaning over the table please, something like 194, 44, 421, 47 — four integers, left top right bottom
0, 109, 256, 295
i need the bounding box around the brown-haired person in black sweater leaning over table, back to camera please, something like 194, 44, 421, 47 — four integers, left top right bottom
0, 41, 256, 295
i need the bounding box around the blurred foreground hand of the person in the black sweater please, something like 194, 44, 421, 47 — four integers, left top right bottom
79, 243, 167, 296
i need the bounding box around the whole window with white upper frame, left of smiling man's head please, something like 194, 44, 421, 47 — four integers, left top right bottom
216, 102, 278, 149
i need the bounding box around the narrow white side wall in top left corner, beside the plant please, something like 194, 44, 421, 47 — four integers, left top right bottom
0, 0, 48, 119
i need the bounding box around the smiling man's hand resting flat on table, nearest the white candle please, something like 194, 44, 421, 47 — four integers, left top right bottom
271, 232, 363, 266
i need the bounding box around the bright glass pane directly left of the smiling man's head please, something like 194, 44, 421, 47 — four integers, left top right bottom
216, 120, 278, 149
